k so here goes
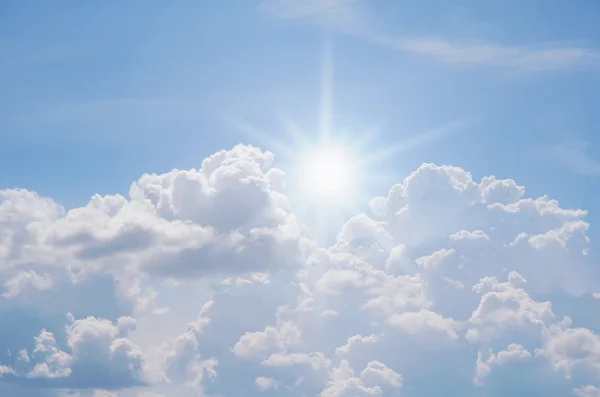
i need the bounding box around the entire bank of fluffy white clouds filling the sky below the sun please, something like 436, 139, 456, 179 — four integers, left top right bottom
0, 145, 600, 397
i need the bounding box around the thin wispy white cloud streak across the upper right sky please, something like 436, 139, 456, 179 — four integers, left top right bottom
262, 0, 600, 71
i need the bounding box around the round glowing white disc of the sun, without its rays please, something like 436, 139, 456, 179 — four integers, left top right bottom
298, 143, 361, 204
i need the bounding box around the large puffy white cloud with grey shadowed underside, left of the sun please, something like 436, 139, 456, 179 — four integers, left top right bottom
0, 146, 309, 286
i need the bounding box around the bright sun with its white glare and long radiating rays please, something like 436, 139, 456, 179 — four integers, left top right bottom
220, 35, 465, 241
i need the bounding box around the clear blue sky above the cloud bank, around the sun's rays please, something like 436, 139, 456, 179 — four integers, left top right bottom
0, 1, 600, 211
